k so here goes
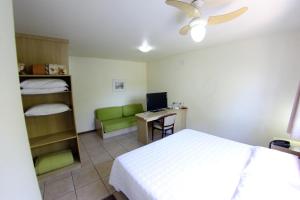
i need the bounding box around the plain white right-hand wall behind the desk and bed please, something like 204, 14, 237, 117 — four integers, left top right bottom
148, 32, 300, 146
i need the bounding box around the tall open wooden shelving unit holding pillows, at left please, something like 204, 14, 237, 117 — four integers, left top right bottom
16, 34, 80, 178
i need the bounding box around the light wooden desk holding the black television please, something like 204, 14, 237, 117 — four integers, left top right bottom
135, 109, 187, 144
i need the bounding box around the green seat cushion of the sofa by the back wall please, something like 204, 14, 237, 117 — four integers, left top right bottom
102, 116, 136, 133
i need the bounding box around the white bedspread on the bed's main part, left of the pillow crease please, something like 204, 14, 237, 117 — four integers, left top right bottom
109, 129, 252, 200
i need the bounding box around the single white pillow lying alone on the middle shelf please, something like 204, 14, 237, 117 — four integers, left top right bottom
25, 103, 70, 116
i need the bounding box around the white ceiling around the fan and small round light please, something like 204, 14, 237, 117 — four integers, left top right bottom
14, 0, 300, 61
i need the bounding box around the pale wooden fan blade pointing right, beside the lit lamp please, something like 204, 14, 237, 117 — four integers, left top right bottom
207, 7, 248, 25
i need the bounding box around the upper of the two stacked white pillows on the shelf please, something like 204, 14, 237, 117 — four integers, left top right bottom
21, 78, 68, 89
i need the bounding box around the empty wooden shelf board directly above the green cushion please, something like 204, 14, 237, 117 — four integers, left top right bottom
29, 130, 77, 148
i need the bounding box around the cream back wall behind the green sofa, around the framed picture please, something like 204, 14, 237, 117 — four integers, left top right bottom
70, 57, 147, 132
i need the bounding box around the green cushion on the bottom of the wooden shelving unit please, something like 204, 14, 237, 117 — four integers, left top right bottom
35, 150, 74, 175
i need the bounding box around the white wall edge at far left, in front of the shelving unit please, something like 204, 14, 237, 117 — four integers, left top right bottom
0, 0, 41, 200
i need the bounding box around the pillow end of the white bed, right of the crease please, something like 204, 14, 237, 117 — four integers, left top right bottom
233, 147, 300, 200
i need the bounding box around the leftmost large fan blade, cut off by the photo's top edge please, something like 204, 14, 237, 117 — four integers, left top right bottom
166, 0, 200, 17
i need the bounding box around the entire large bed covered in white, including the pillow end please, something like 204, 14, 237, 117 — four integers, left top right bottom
109, 129, 300, 200
